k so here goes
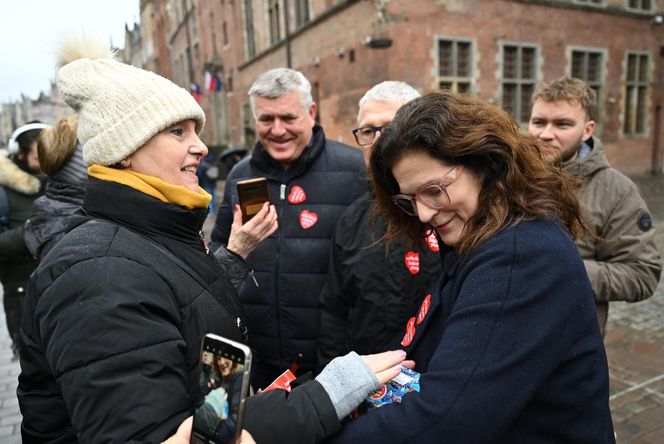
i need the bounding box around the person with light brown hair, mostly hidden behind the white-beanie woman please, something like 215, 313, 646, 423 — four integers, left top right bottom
23, 115, 88, 260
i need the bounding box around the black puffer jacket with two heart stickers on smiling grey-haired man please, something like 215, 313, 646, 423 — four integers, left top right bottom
211, 126, 367, 370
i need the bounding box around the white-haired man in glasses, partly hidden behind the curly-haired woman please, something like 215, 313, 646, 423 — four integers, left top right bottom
318, 81, 440, 368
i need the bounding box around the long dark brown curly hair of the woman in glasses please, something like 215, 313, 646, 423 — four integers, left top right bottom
369, 91, 586, 255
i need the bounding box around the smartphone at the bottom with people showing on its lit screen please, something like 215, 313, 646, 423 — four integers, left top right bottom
191, 333, 251, 444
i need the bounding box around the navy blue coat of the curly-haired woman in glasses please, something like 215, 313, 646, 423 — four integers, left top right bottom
334, 221, 614, 443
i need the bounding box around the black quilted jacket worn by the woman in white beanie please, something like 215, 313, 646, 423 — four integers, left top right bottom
18, 178, 339, 443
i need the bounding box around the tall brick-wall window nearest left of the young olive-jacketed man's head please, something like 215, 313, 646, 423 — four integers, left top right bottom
502, 44, 537, 123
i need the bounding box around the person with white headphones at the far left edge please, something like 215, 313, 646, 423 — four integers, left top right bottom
0, 122, 48, 357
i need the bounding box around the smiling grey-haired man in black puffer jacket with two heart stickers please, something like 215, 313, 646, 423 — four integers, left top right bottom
211, 68, 367, 388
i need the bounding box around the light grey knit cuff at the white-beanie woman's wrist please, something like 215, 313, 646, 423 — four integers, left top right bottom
316, 352, 380, 420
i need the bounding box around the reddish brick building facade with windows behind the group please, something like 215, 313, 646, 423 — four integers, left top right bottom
135, 0, 664, 173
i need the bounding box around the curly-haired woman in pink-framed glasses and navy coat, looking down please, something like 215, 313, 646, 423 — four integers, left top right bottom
334, 92, 614, 443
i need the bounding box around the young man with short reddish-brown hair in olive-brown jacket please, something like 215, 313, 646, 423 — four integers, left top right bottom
528, 77, 662, 334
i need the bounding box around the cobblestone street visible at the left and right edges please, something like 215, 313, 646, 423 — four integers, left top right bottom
0, 175, 664, 444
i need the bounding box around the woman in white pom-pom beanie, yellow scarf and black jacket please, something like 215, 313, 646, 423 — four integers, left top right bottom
18, 33, 410, 443
